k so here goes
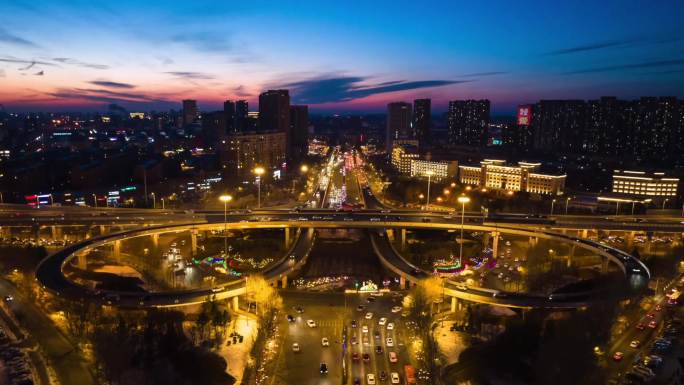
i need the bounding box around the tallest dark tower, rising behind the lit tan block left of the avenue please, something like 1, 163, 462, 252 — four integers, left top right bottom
259, 90, 292, 159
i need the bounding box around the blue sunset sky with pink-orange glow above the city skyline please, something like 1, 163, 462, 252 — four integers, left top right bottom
0, 0, 684, 114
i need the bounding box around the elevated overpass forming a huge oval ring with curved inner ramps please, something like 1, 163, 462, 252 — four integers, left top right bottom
36, 210, 650, 308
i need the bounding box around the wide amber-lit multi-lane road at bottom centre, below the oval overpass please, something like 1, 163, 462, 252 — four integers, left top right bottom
273, 292, 409, 385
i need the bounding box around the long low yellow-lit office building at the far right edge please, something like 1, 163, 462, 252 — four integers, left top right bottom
613, 170, 679, 198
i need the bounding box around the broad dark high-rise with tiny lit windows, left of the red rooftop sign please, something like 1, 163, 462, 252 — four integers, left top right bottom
448, 99, 490, 146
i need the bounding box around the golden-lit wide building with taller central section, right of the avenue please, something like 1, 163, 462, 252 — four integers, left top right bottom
458, 159, 565, 195
